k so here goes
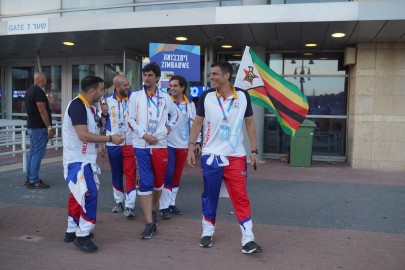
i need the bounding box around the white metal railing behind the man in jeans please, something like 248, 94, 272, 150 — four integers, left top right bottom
0, 119, 62, 172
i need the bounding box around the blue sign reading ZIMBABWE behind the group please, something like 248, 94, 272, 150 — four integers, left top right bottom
149, 43, 201, 84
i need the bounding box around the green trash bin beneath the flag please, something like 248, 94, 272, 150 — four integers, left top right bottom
290, 119, 316, 167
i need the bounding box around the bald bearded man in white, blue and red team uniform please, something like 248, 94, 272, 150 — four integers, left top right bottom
101, 75, 136, 218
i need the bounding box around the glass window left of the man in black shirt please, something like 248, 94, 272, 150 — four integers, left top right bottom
11, 67, 34, 113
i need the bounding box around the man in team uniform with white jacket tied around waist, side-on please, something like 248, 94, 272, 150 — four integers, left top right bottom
62, 76, 124, 252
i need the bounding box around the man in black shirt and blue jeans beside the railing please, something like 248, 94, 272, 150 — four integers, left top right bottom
25, 72, 54, 189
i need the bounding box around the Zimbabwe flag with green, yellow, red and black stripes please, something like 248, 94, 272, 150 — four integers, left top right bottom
235, 46, 308, 136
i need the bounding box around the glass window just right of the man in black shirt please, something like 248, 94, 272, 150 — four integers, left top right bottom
42, 65, 62, 114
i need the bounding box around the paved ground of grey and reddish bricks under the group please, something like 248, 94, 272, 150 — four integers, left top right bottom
0, 150, 405, 269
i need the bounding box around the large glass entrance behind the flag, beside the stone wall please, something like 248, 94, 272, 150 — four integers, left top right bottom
263, 55, 348, 156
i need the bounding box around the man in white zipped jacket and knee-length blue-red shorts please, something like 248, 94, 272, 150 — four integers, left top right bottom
128, 63, 178, 239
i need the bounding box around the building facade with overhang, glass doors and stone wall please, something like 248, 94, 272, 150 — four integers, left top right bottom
0, 0, 405, 170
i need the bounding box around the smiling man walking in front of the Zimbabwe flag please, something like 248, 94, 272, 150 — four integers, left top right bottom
187, 61, 262, 254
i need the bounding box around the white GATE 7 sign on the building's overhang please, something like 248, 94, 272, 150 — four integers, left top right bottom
7, 18, 49, 35
